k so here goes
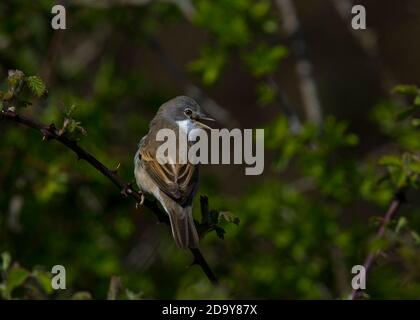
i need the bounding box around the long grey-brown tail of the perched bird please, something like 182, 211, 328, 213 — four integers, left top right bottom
168, 206, 199, 249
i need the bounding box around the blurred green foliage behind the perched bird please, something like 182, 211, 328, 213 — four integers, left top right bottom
0, 0, 420, 299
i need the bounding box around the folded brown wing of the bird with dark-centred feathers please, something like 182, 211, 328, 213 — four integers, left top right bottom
139, 131, 198, 207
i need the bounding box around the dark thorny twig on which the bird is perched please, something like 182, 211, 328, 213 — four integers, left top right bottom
0, 110, 218, 285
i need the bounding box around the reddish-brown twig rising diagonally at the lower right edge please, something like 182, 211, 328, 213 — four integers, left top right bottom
350, 190, 406, 300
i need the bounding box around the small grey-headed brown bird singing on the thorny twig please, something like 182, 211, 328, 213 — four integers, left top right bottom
134, 96, 213, 249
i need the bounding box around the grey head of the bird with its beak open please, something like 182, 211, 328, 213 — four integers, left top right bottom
154, 96, 214, 127
